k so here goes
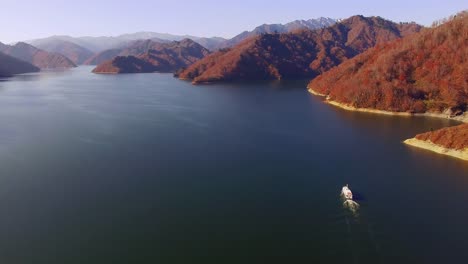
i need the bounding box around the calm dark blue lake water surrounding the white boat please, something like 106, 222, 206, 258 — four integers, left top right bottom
0, 67, 468, 264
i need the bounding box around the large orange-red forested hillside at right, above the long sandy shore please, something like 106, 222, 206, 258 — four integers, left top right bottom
309, 12, 468, 115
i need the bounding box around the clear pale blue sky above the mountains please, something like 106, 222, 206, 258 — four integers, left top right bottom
0, 0, 468, 43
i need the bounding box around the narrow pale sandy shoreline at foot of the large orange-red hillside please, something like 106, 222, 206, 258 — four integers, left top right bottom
308, 88, 468, 123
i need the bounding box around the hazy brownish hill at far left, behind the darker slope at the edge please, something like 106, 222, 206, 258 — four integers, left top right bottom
0, 42, 76, 69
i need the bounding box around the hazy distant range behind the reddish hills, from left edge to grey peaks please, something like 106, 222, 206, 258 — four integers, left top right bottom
0, 18, 336, 72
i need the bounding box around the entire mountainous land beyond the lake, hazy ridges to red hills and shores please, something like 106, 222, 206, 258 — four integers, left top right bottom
0, 11, 468, 160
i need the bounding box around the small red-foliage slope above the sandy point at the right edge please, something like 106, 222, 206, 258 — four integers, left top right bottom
416, 124, 468, 149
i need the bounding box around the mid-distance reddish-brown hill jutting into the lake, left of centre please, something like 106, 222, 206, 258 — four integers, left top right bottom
93, 39, 209, 73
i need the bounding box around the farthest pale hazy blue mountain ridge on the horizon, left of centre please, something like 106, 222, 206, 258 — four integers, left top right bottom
26, 32, 226, 53
